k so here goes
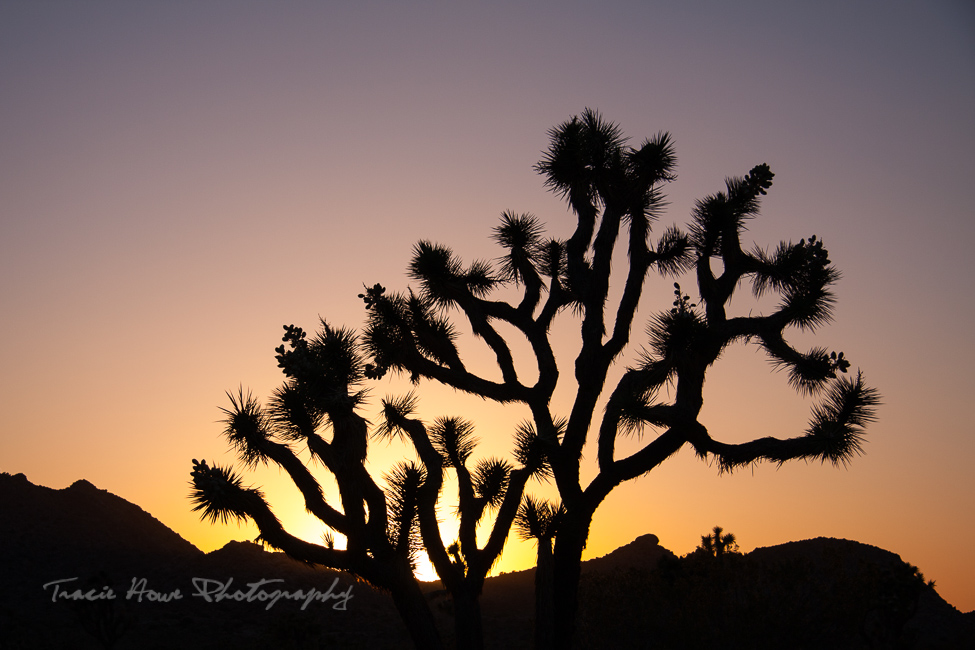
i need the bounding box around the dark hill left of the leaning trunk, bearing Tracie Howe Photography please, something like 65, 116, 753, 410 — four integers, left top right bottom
0, 474, 410, 650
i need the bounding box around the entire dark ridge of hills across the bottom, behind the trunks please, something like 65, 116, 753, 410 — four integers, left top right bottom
0, 473, 975, 650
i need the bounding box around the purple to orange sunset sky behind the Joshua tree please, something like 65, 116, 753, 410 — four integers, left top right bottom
0, 0, 975, 611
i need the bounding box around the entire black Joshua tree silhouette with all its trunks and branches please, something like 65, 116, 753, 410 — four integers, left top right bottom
193, 110, 879, 648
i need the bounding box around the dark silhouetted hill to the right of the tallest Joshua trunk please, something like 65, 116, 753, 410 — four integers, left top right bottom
580, 538, 975, 650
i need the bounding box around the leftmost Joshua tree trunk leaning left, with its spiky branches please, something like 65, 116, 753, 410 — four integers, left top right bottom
191, 322, 442, 648
